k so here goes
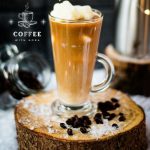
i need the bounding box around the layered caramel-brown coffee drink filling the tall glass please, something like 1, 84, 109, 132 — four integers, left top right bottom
50, 16, 102, 105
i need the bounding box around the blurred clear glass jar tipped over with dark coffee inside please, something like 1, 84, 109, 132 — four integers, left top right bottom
0, 44, 51, 109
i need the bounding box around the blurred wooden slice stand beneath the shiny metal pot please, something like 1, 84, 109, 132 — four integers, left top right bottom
105, 45, 150, 96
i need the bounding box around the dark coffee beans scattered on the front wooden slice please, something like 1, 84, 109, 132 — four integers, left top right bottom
60, 98, 126, 136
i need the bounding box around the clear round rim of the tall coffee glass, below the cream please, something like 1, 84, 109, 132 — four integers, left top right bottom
49, 9, 103, 23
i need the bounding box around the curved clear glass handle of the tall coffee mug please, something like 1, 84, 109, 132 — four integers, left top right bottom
91, 53, 115, 93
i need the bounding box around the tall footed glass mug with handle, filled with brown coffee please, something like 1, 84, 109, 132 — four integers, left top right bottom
49, 10, 114, 115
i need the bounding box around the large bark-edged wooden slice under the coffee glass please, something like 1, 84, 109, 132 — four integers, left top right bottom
15, 89, 147, 150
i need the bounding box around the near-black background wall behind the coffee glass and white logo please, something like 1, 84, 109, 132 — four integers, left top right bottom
0, 0, 115, 69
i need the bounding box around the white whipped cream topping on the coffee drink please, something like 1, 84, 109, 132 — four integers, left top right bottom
51, 1, 95, 20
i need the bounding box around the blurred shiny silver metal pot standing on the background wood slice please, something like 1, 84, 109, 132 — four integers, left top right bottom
115, 0, 150, 59
